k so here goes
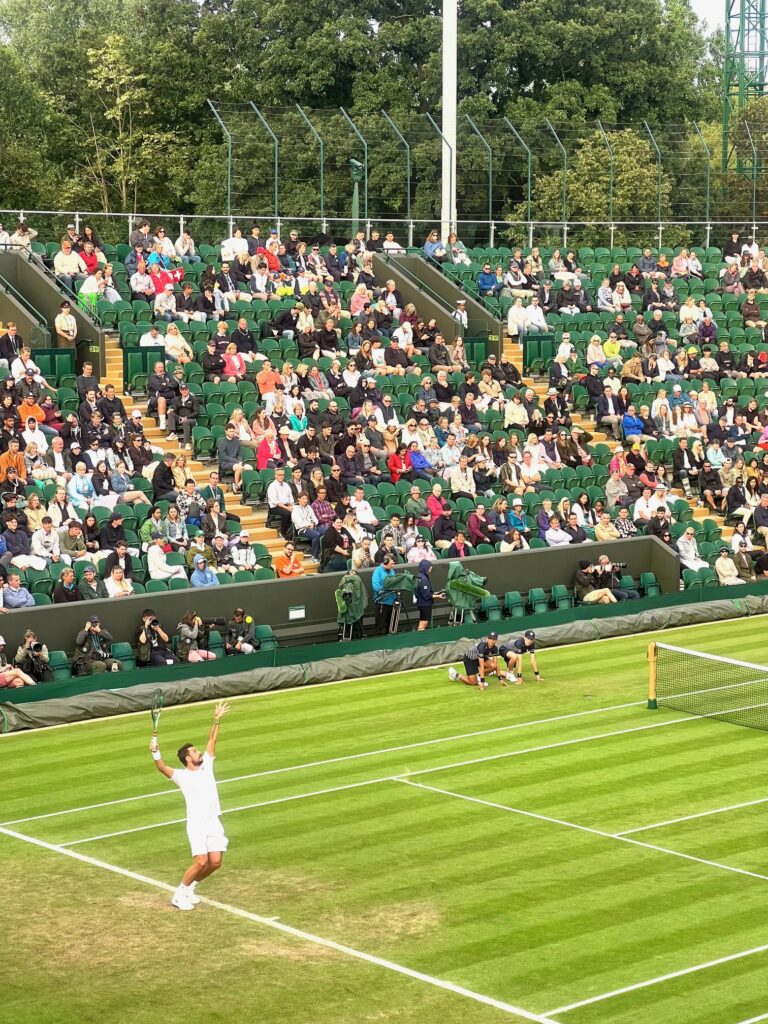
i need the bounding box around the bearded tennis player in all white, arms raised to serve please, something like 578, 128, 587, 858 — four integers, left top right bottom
150, 701, 229, 910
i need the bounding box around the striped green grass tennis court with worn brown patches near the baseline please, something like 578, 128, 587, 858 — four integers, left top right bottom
0, 618, 768, 1024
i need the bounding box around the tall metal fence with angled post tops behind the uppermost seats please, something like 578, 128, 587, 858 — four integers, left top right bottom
7, 110, 768, 248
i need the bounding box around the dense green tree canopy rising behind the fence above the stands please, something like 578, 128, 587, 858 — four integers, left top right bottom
0, 0, 720, 230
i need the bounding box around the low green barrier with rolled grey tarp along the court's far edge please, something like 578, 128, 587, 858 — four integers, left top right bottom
0, 587, 768, 731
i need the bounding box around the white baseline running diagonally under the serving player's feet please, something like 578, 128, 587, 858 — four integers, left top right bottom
0, 827, 557, 1024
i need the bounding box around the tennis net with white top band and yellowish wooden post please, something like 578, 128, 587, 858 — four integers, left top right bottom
648, 642, 768, 730
